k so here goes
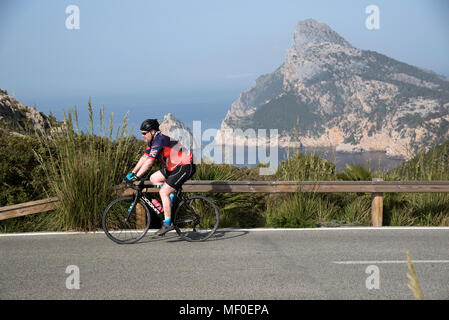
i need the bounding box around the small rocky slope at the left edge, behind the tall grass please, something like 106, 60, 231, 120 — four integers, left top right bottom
0, 89, 57, 134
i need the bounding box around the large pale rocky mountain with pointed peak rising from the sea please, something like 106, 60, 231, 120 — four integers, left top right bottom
220, 19, 449, 158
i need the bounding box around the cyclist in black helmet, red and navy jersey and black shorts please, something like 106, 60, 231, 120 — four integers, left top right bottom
126, 119, 196, 236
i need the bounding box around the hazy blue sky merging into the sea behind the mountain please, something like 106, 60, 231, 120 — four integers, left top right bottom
0, 0, 449, 131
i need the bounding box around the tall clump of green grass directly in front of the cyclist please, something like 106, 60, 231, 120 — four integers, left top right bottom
36, 100, 141, 231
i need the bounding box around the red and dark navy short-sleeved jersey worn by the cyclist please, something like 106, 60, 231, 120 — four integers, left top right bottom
145, 131, 192, 171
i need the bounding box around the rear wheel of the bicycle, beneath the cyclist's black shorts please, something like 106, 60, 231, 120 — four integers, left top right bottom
173, 196, 219, 241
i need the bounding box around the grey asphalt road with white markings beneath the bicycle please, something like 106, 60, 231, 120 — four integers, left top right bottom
0, 228, 449, 300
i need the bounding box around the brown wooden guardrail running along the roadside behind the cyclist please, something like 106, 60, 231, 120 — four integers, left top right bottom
0, 179, 449, 227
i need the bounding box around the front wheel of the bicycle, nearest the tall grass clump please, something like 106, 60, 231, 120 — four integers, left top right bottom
102, 196, 150, 244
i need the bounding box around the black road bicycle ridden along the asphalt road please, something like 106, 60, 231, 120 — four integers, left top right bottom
102, 180, 219, 244
